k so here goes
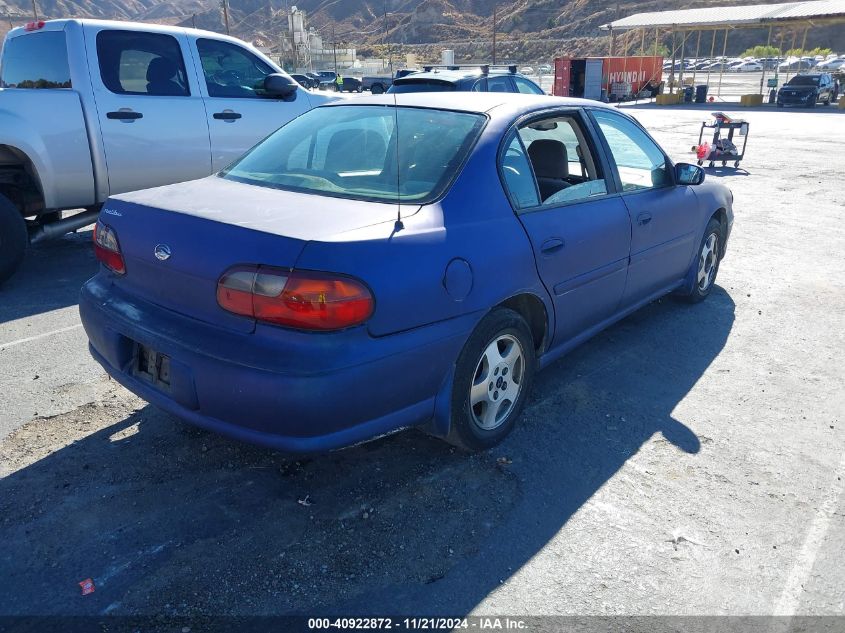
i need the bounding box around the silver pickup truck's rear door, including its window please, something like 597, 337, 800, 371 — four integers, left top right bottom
84, 25, 211, 195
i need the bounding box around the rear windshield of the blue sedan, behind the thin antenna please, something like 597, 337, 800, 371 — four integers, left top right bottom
221, 105, 485, 204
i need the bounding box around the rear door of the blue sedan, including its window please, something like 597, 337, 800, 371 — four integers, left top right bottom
501, 110, 631, 345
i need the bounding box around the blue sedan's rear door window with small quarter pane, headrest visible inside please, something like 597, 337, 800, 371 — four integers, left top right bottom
502, 113, 607, 209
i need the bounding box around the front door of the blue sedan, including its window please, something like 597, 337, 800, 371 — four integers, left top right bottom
592, 109, 698, 305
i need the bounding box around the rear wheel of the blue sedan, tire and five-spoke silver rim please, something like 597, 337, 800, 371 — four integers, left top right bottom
446, 308, 536, 451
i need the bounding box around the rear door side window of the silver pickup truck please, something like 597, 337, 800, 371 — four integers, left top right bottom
97, 31, 191, 97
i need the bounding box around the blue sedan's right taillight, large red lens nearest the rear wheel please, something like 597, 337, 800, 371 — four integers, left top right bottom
217, 266, 374, 331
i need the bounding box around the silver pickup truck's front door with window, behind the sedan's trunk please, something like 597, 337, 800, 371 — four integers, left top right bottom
192, 37, 311, 171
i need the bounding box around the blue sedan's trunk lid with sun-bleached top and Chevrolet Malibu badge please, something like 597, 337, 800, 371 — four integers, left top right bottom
100, 176, 406, 332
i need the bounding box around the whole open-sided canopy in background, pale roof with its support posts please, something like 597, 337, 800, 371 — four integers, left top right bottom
599, 0, 845, 100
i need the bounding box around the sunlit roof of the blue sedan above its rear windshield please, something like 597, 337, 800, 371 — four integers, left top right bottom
321, 92, 615, 114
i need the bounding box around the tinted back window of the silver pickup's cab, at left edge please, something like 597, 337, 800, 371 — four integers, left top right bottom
0, 31, 71, 89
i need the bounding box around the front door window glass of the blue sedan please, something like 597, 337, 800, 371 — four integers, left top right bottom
593, 110, 672, 191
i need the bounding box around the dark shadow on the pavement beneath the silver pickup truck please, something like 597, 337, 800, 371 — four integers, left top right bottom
0, 229, 98, 323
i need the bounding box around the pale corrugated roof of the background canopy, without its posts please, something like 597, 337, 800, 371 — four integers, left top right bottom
599, 0, 845, 32
